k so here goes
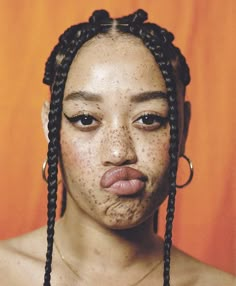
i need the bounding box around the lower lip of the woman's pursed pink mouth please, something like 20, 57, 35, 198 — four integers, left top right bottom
105, 179, 145, 196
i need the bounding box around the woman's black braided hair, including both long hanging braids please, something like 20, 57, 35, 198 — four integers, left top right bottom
43, 9, 190, 286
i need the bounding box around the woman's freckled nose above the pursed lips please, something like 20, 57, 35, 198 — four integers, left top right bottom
101, 126, 137, 166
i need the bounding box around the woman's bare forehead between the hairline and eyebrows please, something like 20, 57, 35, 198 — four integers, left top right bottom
65, 32, 166, 95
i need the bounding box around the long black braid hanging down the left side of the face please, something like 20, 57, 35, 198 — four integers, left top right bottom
44, 19, 109, 286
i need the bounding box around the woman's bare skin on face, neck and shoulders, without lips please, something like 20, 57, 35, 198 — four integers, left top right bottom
0, 32, 235, 286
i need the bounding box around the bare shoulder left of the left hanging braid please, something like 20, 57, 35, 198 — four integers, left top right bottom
0, 229, 45, 286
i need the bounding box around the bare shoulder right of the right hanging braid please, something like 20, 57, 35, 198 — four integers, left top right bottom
172, 248, 236, 286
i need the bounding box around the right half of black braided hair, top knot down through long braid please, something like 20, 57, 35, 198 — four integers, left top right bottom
115, 10, 190, 286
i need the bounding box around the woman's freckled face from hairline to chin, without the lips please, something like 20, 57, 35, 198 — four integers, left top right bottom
61, 35, 169, 229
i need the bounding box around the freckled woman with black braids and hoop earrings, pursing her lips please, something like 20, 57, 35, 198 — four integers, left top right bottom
0, 10, 235, 286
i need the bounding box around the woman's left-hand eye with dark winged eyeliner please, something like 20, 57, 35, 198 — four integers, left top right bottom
64, 113, 99, 131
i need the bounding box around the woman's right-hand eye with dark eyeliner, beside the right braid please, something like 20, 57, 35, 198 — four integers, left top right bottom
134, 113, 168, 130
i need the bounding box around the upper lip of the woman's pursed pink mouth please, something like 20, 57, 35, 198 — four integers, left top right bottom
100, 166, 147, 188
